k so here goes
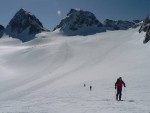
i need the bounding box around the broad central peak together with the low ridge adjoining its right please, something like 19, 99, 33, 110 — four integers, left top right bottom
54, 9, 140, 35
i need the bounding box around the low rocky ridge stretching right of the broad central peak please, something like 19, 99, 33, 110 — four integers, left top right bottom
104, 19, 140, 30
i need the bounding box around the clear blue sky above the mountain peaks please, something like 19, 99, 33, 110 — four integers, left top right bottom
0, 0, 150, 31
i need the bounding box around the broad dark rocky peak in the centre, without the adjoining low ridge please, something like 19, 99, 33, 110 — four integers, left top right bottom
54, 9, 105, 35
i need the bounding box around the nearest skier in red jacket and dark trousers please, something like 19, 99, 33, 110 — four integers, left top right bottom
115, 77, 126, 101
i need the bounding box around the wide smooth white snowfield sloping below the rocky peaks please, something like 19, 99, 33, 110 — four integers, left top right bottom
0, 28, 150, 113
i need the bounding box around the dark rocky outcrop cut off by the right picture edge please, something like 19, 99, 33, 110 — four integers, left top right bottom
139, 15, 150, 43
